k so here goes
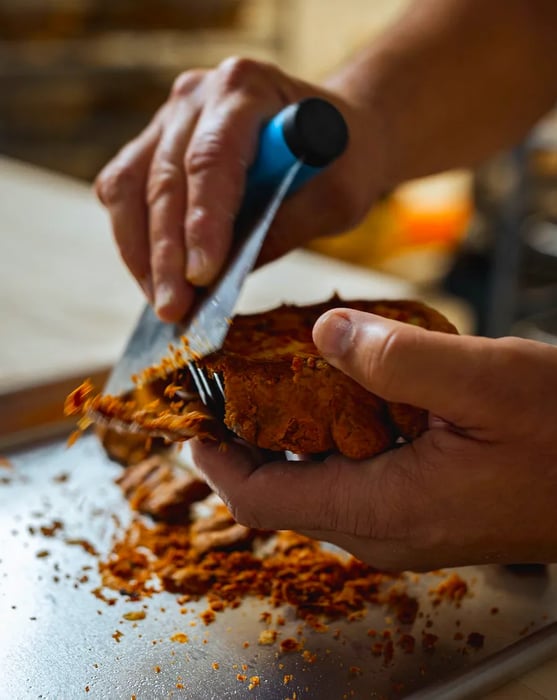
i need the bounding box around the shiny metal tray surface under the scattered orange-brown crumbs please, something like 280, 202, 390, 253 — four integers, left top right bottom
0, 380, 557, 700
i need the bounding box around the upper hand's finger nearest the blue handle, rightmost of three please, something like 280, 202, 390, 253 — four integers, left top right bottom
186, 59, 287, 285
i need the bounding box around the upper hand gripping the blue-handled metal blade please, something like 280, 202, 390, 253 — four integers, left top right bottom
96, 58, 381, 321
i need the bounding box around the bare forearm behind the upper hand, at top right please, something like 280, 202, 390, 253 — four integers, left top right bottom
328, 0, 557, 188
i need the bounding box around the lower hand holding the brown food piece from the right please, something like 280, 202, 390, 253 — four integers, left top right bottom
192, 309, 557, 570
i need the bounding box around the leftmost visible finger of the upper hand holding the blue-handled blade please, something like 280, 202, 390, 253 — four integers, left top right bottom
95, 111, 162, 303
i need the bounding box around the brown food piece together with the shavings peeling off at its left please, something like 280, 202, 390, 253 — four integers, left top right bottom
67, 297, 456, 459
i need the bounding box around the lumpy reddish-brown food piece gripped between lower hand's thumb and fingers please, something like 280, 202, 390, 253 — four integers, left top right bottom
200, 297, 456, 459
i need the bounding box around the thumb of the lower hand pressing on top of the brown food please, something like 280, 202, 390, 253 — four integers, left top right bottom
313, 309, 506, 429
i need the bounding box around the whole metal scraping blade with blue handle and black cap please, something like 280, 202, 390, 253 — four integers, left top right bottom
104, 98, 348, 395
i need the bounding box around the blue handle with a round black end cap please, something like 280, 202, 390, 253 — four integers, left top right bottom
246, 97, 348, 199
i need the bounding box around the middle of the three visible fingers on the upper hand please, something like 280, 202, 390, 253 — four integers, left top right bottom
147, 98, 197, 322
